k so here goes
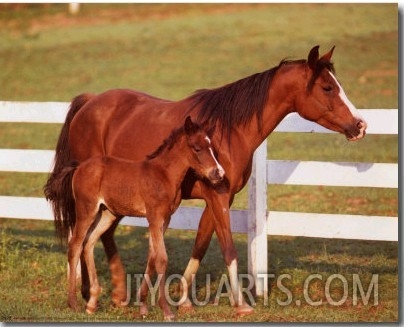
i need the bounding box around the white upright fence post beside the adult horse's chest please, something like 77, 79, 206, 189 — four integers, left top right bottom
248, 140, 268, 296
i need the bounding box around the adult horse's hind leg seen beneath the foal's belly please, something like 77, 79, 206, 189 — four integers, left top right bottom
101, 218, 127, 306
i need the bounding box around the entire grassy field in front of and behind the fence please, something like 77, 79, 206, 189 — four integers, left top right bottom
0, 4, 398, 322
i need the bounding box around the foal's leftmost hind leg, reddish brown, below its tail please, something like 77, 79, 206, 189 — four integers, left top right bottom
68, 206, 96, 310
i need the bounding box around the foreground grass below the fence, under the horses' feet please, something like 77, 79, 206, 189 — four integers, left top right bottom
0, 219, 398, 322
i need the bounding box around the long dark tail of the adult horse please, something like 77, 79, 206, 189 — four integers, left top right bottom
44, 94, 93, 242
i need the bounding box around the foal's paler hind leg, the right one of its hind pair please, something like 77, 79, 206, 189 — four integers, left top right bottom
83, 211, 116, 314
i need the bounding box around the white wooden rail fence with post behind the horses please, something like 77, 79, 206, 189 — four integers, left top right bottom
0, 101, 398, 295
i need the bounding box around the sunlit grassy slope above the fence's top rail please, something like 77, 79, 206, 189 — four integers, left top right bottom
0, 4, 398, 108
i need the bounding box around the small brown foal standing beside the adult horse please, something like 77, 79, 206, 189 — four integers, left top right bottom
61, 117, 224, 320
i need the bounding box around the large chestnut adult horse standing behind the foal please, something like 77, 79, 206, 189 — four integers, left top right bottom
45, 46, 367, 314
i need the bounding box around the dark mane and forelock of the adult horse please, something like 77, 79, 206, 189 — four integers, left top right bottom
190, 59, 334, 140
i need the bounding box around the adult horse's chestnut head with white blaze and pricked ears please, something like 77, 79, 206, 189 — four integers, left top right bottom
295, 46, 367, 141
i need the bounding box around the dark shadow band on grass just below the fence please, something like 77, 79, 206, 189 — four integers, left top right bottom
2, 219, 398, 281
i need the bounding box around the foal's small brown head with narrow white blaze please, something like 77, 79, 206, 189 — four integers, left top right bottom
184, 116, 225, 184
